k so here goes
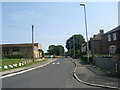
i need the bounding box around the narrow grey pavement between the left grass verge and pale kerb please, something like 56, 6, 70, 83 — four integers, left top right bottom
1, 59, 55, 76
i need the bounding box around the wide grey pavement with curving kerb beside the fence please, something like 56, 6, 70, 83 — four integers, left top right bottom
74, 59, 120, 89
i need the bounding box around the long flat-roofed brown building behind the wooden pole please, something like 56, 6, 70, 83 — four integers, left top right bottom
0, 43, 42, 58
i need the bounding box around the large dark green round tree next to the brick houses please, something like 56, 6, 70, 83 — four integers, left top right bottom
66, 34, 85, 57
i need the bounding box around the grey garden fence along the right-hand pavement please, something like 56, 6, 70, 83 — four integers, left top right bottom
93, 57, 120, 74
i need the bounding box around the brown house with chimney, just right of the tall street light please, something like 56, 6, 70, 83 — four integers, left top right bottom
89, 30, 104, 54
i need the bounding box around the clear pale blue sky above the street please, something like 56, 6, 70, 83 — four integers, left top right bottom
0, 2, 118, 52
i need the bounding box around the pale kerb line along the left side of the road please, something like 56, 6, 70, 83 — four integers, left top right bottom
0, 59, 56, 79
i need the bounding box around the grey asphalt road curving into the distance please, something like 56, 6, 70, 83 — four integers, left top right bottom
2, 57, 95, 88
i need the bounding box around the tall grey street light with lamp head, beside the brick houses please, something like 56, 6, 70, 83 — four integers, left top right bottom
80, 4, 89, 63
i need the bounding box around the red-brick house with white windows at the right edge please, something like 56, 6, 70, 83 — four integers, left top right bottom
102, 26, 120, 54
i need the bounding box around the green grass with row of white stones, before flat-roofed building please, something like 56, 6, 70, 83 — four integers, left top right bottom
0, 59, 46, 72
